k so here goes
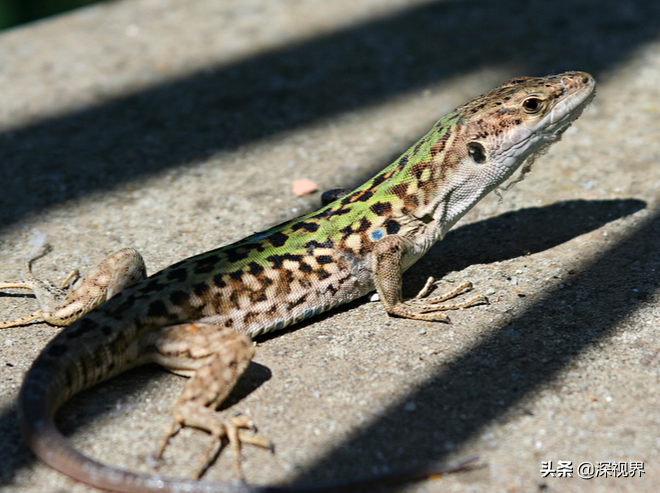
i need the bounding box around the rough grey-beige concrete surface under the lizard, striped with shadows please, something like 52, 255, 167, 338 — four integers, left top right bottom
0, 0, 660, 493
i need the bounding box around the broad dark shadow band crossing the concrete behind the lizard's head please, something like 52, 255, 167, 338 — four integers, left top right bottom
0, 0, 660, 228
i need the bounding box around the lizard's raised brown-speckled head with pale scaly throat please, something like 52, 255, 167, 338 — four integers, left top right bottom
431, 72, 596, 233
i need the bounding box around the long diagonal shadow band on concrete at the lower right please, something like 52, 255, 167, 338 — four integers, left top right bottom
288, 209, 660, 483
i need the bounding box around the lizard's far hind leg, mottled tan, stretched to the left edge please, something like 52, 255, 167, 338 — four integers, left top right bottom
0, 248, 147, 329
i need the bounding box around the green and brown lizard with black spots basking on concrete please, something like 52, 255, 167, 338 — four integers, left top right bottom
5, 72, 595, 493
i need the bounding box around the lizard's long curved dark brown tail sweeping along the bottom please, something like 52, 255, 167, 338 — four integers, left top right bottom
17, 322, 474, 493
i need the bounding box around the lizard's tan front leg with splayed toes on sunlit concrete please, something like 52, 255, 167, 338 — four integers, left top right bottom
373, 235, 488, 322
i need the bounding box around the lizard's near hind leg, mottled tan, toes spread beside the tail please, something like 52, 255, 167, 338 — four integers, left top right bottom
153, 322, 273, 480
